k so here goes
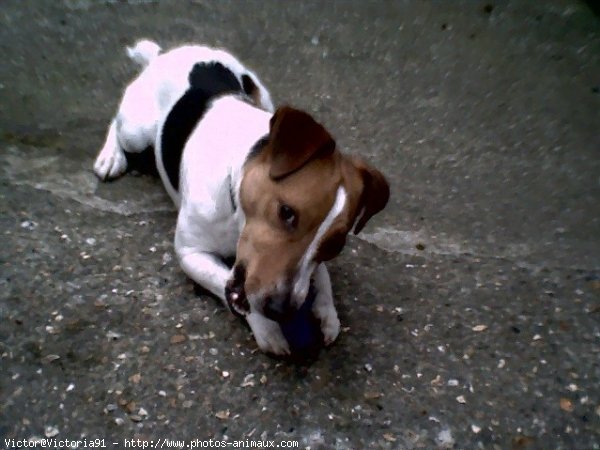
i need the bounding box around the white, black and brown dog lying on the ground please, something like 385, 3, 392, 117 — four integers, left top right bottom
94, 40, 389, 355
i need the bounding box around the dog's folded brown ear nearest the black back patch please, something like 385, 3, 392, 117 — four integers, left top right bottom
269, 106, 335, 180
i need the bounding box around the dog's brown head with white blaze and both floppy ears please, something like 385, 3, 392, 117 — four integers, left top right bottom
226, 107, 389, 320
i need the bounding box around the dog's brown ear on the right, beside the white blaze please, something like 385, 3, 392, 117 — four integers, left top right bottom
352, 158, 390, 234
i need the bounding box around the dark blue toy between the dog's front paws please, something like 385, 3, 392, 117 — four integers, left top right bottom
280, 284, 323, 356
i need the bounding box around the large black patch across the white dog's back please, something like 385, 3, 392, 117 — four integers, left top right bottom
160, 63, 242, 190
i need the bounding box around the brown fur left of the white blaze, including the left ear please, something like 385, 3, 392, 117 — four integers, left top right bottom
236, 107, 341, 306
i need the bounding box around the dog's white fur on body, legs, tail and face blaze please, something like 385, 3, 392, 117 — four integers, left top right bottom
94, 41, 346, 354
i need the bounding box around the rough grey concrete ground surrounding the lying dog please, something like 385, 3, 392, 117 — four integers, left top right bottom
0, 0, 600, 450
